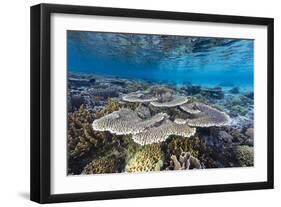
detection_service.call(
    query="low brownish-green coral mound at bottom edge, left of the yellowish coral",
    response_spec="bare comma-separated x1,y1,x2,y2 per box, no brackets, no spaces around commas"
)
81,156,118,174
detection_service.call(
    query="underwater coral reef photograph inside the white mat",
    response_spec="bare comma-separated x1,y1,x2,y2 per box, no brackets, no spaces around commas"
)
67,31,254,175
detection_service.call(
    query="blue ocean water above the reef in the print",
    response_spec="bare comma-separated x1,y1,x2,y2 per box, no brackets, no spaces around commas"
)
67,31,254,89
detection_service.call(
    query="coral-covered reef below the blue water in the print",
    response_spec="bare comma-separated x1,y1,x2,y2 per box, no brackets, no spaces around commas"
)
67,73,254,175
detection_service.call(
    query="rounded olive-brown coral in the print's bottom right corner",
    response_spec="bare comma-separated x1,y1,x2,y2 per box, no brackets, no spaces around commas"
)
234,145,254,167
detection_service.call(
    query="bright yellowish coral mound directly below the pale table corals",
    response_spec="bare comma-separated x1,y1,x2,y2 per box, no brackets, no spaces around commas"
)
125,144,163,172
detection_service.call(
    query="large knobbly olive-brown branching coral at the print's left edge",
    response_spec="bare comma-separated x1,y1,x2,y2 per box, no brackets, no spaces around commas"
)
67,105,104,158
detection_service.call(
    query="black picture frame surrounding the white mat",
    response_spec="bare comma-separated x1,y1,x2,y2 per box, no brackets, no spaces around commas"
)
30,4,274,203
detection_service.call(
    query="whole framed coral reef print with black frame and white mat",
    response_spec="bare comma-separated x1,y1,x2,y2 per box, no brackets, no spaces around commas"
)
31,4,273,203
